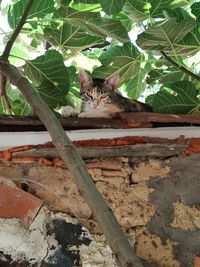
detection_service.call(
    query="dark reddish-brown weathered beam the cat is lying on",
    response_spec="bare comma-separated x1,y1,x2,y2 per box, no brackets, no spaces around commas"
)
0,112,200,131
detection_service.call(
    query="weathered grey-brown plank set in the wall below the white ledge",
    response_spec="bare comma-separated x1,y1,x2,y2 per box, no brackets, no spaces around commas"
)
12,144,187,159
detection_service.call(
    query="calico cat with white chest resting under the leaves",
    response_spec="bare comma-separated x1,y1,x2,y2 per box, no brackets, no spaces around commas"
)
61,70,151,118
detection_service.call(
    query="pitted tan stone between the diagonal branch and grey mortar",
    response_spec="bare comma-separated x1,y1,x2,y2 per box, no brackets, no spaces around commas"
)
96,182,155,232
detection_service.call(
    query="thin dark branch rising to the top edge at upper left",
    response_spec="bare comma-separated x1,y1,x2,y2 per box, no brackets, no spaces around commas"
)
1,0,35,60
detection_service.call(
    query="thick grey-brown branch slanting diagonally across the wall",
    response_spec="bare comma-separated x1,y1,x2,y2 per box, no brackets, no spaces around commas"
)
0,61,143,267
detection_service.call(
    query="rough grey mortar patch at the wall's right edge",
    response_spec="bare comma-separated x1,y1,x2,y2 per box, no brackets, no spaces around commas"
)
147,154,200,267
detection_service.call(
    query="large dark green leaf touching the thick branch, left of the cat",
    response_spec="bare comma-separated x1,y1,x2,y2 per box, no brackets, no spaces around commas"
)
24,50,69,108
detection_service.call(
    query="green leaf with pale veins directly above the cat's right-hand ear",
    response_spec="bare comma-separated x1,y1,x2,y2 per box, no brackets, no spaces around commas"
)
93,43,143,83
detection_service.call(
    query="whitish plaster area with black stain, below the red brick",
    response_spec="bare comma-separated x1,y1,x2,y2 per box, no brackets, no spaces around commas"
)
0,208,117,267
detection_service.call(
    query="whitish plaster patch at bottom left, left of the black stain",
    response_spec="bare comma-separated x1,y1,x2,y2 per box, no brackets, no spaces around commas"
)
0,209,58,266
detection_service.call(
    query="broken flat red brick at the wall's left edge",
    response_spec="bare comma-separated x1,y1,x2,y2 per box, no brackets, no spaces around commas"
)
0,184,42,227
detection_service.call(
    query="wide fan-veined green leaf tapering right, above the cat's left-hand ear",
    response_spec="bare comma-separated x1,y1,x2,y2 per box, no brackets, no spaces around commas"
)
44,22,103,52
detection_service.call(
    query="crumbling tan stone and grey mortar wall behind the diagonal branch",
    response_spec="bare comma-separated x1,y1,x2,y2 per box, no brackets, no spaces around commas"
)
0,149,200,267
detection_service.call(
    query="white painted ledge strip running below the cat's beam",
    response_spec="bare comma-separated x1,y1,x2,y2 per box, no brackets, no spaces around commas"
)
0,126,200,150
